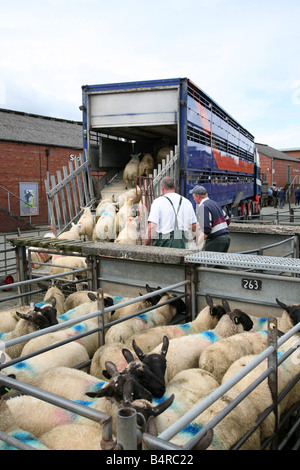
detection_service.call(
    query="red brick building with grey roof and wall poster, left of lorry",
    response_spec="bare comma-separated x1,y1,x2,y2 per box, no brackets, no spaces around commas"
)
0,109,83,232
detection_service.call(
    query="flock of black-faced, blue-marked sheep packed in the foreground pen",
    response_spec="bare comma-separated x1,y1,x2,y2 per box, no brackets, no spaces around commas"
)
0,280,300,450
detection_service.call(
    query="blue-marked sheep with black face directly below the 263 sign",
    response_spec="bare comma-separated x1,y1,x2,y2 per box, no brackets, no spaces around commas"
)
152,309,253,383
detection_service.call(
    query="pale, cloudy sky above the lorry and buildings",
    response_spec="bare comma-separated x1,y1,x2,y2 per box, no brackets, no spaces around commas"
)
0,0,300,149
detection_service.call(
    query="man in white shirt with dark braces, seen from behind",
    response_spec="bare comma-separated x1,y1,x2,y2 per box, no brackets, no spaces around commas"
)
144,176,197,248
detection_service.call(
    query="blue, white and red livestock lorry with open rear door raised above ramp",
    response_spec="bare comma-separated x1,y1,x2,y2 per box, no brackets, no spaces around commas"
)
80,78,261,216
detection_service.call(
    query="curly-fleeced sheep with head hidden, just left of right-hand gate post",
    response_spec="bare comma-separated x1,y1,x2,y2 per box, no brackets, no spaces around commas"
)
199,331,268,383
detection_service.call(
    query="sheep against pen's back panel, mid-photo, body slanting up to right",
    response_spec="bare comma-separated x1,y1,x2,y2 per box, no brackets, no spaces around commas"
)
105,294,186,344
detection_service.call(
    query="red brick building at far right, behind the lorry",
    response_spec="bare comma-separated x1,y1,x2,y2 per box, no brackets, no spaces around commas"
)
256,144,300,187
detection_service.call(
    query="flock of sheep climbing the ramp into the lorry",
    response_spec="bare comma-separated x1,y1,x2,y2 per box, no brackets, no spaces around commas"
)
31,147,172,279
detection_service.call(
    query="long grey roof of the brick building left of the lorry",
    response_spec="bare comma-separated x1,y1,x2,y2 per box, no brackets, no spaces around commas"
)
0,108,83,149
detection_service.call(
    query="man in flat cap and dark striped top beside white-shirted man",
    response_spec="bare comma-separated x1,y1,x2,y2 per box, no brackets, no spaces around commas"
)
190,186,230,253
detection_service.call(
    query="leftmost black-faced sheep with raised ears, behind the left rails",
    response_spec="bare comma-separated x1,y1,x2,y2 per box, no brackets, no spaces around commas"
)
0,298,58,359
